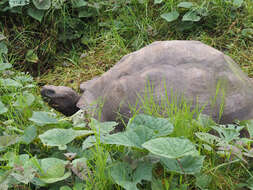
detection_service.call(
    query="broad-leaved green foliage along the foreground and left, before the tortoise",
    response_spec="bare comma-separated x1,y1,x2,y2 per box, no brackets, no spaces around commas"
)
0,39,252,190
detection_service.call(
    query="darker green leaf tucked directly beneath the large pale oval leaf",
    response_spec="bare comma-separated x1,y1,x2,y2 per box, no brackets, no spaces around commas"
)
161,155,205,174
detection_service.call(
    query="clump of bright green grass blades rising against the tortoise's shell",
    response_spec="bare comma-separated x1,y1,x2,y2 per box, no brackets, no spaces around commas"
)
126,83,210,138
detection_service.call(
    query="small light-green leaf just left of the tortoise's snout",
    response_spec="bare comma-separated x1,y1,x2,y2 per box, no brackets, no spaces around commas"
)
13,91,35,109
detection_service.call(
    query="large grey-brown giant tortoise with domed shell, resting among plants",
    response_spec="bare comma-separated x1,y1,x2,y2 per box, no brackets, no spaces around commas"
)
41,40,253,124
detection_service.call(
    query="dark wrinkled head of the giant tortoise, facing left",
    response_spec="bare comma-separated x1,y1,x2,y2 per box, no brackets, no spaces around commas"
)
40,85,80,116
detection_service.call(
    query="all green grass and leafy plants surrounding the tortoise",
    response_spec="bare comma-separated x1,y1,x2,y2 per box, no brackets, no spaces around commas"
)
0,0,253,190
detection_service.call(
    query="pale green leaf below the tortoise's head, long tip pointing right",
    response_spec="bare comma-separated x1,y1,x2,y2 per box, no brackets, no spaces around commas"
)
39,129,94,150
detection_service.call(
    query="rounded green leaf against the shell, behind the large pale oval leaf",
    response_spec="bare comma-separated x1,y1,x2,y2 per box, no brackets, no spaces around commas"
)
127,114,174,138
